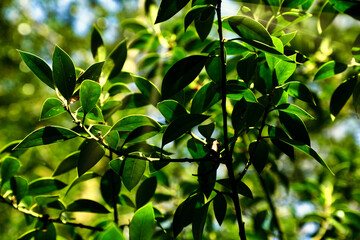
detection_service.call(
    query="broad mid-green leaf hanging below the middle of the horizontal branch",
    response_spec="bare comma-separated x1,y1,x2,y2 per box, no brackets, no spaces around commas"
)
122,157,146,191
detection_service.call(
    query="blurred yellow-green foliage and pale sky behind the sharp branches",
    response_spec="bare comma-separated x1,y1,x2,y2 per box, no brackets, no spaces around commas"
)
0,0,360,239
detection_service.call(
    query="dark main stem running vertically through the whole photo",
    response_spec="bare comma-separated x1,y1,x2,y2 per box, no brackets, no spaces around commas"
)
216,0,246,240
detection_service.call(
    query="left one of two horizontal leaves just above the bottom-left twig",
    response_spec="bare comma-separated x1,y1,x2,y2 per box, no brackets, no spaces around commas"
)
27,178,67,196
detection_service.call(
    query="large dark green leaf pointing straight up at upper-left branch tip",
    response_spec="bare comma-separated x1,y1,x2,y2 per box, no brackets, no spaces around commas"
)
52,46,76,100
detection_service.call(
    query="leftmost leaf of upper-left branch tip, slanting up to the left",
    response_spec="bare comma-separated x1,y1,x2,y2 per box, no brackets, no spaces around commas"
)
18,50,55,89
